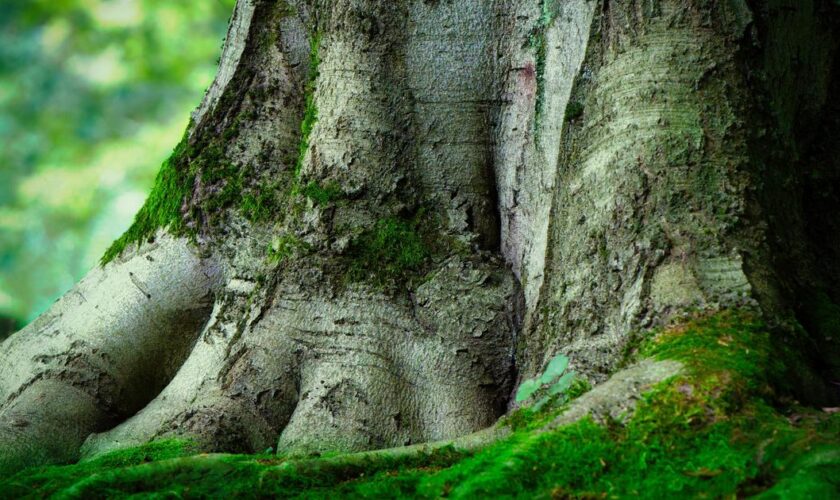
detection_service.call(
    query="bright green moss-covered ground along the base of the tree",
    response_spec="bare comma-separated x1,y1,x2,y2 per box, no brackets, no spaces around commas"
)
0,312,840,498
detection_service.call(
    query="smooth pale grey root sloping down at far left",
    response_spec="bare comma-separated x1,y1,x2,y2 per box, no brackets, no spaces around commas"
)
0,236,220,469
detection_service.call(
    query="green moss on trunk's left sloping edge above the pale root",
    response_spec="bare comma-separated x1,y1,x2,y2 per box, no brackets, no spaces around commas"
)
101,23,310,265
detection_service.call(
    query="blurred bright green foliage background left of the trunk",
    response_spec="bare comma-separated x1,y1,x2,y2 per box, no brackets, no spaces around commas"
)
0,0,234,338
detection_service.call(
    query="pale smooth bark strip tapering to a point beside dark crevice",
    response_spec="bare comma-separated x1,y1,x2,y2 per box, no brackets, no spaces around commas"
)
495,0,599,324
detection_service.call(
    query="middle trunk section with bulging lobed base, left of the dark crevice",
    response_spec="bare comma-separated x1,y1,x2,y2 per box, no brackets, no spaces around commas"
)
84,1,518,460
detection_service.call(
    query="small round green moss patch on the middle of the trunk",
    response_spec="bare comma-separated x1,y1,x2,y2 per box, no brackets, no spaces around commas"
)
347,210,431,285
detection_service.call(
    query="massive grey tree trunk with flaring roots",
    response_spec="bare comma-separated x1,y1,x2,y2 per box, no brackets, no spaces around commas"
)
0,0,840,484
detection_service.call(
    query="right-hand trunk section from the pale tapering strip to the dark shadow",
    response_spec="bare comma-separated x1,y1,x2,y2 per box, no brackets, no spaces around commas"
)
497,0,838,386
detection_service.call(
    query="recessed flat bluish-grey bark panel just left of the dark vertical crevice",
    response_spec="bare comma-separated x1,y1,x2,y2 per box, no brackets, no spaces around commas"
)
403,2,500,250
